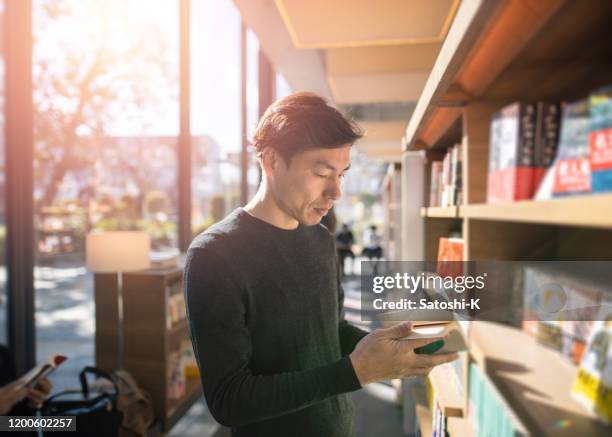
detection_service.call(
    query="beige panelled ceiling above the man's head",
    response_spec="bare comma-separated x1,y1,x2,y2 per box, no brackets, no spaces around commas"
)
234,0,459,160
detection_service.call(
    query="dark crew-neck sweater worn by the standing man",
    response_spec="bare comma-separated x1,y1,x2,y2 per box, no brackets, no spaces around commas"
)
185,208,367,437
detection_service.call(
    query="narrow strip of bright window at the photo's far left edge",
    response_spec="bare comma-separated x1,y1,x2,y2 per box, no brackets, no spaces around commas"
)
0,1,8,345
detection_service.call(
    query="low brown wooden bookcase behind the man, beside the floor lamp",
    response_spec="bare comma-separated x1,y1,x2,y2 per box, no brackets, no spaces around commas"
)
95,267,202,432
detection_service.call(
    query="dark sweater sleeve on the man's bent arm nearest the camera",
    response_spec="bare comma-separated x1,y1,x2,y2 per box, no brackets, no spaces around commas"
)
185,248,361,427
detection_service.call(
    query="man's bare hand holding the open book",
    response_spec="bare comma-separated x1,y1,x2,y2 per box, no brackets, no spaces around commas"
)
350,322,457,386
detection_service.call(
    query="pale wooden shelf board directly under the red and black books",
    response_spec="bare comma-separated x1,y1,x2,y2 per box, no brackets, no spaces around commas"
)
459,194,612,228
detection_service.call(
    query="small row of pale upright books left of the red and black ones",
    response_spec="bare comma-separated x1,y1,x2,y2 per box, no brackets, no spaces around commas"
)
429,144,462,207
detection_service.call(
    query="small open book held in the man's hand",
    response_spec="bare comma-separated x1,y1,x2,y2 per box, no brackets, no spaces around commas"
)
404,320,467,355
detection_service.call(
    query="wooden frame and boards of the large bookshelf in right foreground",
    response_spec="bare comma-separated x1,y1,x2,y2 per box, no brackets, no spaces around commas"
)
402,0,612,436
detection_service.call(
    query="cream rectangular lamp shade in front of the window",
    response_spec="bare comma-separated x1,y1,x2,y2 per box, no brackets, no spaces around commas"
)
85,231,151,273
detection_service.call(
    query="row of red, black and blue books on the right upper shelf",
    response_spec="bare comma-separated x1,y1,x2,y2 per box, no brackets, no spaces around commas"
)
488,87,612,203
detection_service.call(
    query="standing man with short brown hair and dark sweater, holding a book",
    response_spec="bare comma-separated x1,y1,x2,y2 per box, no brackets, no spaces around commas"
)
185,93,455,437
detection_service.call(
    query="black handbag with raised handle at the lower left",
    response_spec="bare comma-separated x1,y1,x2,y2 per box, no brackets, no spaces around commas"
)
41,366,122,437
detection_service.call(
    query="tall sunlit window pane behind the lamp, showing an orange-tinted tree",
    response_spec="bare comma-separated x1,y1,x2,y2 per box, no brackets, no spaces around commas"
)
33,0,179,386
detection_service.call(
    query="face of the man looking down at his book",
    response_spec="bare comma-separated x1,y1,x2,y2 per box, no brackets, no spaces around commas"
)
269,144,351,225
